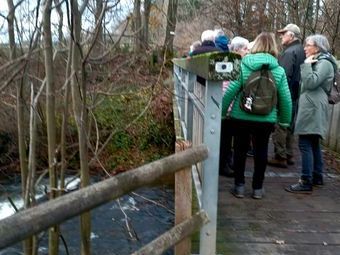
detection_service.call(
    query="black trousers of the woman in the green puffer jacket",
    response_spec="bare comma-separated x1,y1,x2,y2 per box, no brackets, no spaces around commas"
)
233,119,274,189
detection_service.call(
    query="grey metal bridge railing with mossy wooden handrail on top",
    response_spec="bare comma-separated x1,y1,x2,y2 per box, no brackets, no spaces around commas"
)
173,53,240,255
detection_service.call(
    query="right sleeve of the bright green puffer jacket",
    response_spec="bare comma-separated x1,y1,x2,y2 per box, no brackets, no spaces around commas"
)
277,73,292,127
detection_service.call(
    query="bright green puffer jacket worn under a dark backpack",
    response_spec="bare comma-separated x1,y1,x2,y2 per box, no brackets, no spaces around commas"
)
222,53,292,127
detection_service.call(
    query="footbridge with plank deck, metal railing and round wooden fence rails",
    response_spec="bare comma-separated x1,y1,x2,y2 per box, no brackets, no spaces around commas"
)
0,53,340,255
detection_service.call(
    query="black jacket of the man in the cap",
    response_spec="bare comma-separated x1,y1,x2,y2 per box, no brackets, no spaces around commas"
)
278,40,306,101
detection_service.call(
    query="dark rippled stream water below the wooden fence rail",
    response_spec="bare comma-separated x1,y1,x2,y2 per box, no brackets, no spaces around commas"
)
0,177,174,255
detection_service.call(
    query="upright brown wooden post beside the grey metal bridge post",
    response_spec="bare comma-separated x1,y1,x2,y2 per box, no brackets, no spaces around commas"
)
175,140,192,255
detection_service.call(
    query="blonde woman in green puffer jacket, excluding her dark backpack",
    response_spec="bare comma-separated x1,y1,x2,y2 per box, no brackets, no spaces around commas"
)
222,32,292,199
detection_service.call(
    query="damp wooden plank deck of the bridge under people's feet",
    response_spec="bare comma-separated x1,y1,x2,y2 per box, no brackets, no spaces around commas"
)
216,140,340,255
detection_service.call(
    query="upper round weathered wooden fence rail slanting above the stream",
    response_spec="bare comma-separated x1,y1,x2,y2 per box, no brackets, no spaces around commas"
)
0,145,208,249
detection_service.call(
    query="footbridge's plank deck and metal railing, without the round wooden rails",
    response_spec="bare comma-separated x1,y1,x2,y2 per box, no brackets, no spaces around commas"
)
174,53,340,255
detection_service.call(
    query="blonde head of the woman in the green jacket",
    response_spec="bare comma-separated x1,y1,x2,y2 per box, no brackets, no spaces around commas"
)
250,32,279,57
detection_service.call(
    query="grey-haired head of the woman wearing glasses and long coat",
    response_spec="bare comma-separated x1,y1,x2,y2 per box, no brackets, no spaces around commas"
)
304,34,330,57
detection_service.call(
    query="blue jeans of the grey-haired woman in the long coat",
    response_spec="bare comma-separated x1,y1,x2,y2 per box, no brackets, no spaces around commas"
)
299,135,323,182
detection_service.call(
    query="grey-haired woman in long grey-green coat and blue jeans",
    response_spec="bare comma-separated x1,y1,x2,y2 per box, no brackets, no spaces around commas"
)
286,34,336,193
